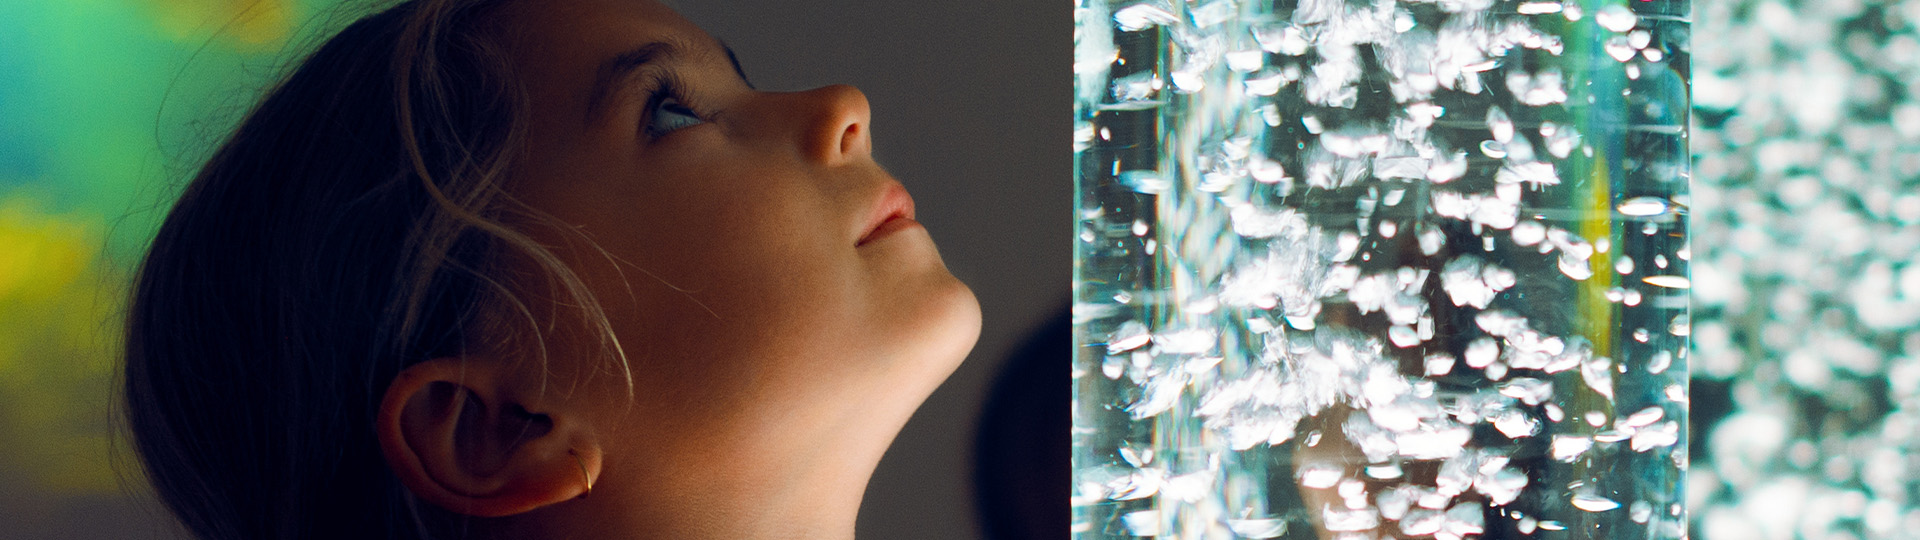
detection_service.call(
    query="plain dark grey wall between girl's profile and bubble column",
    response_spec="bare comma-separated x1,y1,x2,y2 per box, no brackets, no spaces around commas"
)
674,0,1073,540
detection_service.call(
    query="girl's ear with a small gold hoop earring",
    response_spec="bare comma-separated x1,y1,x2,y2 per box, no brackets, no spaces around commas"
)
374,357,601,517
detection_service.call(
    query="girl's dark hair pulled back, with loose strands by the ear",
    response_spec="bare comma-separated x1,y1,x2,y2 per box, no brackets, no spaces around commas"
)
123,0,632,538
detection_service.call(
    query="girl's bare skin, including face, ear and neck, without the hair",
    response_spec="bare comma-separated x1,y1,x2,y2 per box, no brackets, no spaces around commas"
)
368,0,979,538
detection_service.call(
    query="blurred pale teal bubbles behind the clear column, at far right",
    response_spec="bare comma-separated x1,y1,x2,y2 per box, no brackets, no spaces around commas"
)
1678,0,1920,540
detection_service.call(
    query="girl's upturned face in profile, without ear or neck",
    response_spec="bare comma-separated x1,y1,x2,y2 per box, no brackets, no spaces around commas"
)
487,0,979,445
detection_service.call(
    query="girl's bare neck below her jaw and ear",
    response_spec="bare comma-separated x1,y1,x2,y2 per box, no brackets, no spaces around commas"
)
501,390,912,540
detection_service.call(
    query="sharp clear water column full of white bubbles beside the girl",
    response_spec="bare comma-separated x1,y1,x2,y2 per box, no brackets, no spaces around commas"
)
1071,0,1690,540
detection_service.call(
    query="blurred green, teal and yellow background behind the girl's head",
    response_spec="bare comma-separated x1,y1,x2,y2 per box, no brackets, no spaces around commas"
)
0,0,326,538
